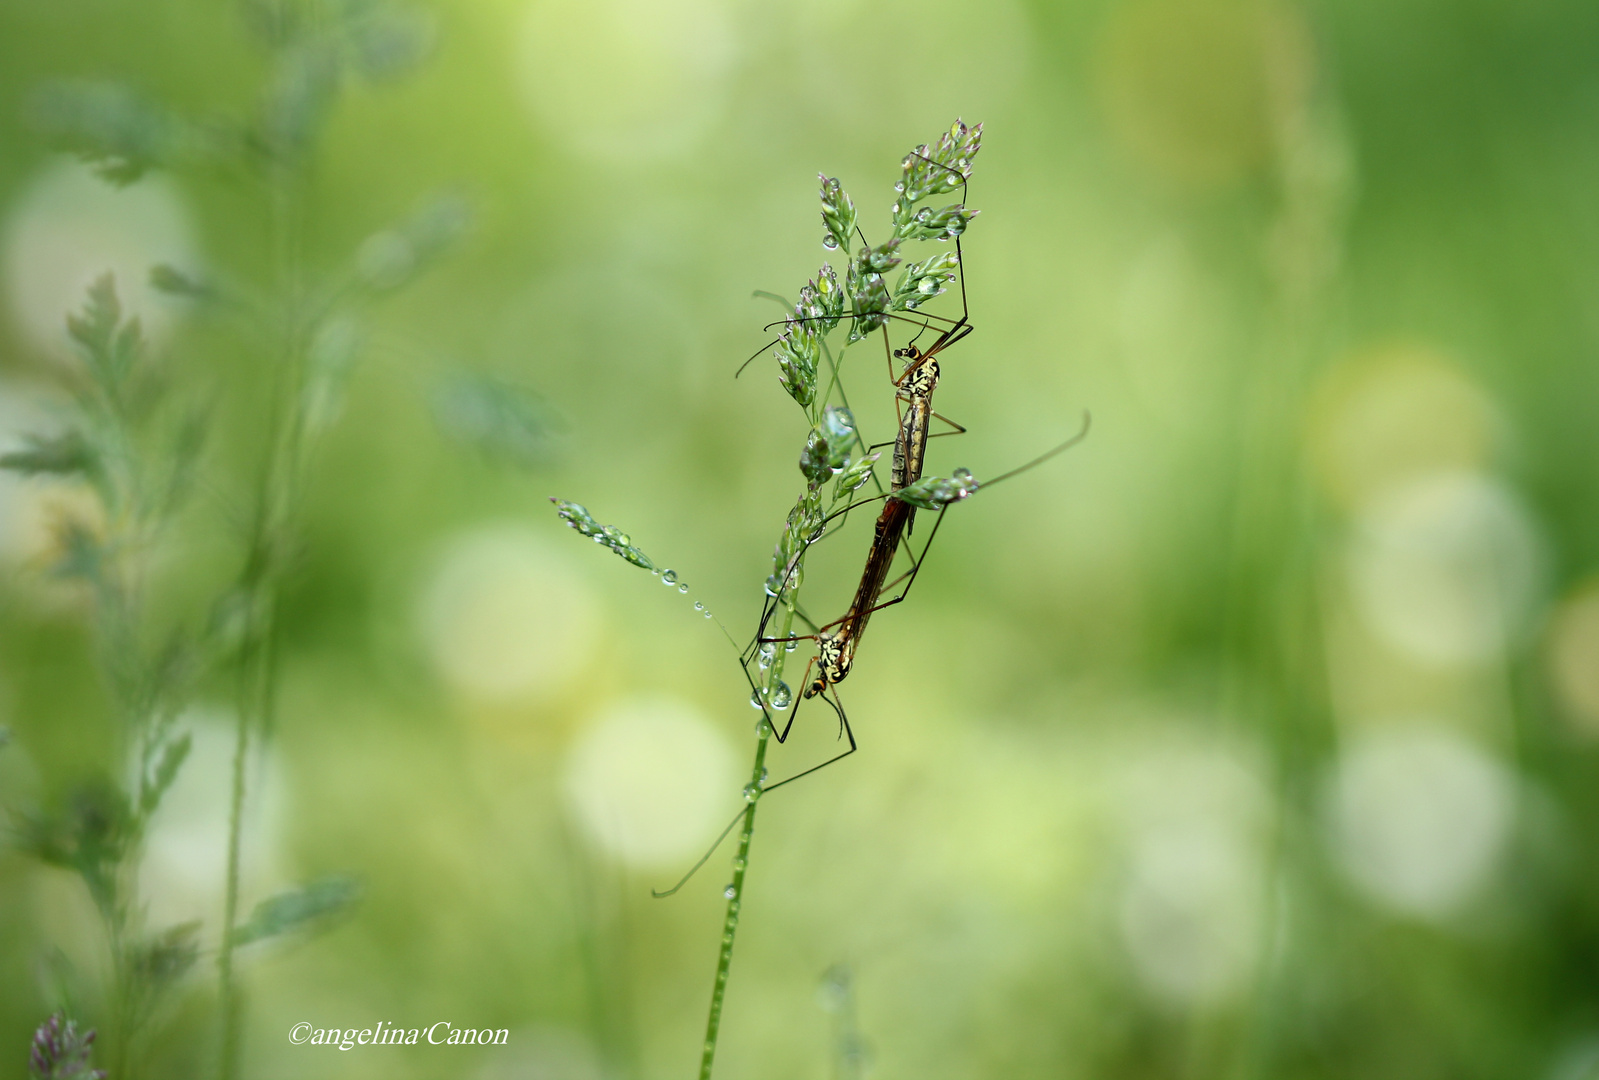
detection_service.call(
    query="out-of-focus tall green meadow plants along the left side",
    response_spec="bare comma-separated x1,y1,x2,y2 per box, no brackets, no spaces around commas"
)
0,0,463,1080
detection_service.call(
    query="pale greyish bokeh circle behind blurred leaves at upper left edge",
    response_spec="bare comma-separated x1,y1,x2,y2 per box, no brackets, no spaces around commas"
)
0,160,198,357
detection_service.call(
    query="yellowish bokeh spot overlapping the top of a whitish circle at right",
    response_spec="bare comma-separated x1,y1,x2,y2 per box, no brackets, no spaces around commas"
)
1310,344,1500,510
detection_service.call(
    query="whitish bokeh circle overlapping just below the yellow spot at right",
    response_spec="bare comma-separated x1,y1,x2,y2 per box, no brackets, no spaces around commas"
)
1348,470,1540,667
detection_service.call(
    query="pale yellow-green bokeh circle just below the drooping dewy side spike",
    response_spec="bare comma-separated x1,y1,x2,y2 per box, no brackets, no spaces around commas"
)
419,525,600,704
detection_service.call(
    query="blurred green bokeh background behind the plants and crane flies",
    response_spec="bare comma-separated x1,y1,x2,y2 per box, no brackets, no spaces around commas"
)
0,0,1599,1080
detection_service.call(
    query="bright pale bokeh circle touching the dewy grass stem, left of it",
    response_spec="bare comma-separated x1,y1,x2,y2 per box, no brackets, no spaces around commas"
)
566,699,737,869
